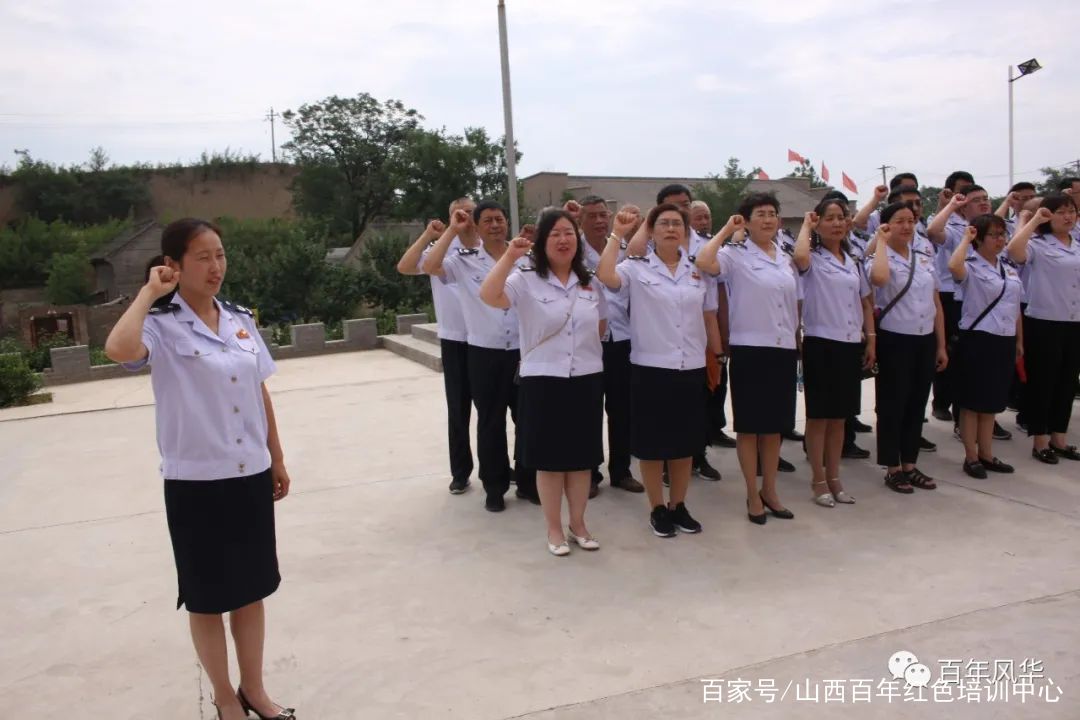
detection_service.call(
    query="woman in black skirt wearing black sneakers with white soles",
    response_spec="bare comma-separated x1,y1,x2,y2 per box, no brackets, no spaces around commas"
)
596,203,720,538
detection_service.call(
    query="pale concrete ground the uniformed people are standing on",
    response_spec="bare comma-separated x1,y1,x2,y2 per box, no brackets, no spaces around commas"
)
0,351,1080,720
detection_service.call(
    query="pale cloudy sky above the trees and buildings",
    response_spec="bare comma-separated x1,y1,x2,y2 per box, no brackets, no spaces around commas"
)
0,0,1080,200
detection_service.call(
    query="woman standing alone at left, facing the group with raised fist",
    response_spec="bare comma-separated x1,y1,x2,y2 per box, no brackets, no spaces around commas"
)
105,218,293,720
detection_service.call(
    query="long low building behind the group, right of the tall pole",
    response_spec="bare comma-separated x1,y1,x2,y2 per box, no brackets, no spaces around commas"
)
522,173,827,233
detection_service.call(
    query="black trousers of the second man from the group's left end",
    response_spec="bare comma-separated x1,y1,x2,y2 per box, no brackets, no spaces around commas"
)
468,345,536,495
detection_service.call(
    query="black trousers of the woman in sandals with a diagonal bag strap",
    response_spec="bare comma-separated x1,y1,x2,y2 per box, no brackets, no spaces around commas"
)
874,329,937,467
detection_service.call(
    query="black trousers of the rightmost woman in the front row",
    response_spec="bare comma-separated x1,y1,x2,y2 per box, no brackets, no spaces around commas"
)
1024,317,1080,435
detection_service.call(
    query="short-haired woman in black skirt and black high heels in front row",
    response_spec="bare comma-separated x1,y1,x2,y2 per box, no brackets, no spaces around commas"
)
697,192,798,525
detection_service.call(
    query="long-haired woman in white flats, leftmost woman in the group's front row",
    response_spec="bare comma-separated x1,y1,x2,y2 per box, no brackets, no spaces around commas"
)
480,210,607,556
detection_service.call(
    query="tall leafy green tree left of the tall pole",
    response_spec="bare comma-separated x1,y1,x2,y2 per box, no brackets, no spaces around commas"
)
282,93,421,237
